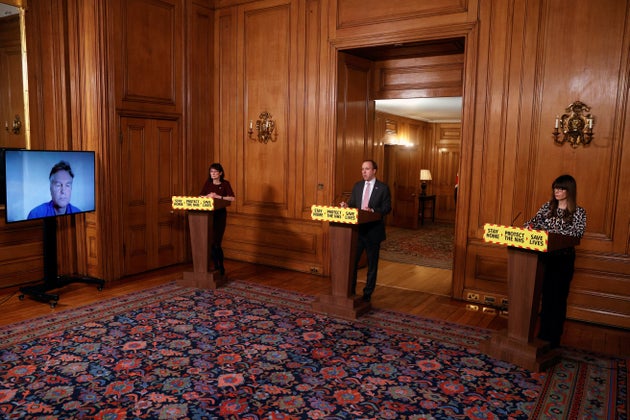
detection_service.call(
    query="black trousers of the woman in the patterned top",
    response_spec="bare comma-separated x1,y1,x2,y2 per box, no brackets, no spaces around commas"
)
538,248,575,347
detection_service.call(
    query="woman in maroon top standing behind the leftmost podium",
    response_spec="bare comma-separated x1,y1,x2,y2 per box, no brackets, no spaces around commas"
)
201,162,235,275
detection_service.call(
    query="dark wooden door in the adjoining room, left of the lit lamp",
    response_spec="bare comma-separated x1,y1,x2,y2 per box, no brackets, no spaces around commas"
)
386,146,420,229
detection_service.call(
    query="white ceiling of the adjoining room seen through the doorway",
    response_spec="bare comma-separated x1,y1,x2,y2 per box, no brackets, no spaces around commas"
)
376,97,462,123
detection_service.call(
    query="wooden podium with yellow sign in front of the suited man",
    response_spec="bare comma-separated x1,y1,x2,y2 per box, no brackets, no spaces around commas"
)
311,206,382,319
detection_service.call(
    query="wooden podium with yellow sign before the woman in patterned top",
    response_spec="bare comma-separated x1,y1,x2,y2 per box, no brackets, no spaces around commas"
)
480,224,580,372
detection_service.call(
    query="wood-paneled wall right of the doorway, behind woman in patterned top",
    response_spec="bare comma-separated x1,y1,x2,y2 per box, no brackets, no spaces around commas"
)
463,1,630,327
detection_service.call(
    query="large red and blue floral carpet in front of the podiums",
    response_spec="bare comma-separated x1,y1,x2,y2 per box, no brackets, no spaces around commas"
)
0,281,628,419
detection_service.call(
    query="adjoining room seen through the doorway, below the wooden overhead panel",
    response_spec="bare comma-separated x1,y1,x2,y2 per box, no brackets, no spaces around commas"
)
375,98,461,296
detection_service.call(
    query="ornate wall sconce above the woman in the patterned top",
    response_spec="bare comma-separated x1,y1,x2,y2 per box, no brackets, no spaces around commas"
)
552,101,593,147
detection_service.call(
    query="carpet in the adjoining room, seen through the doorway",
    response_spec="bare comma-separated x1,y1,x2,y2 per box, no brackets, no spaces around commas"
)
380,223,455,269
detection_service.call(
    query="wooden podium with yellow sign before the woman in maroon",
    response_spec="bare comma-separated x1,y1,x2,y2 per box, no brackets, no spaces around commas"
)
172,196,230,289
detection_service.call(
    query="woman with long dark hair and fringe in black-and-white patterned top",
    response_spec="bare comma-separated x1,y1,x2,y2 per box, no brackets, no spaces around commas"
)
525,175,586,348
